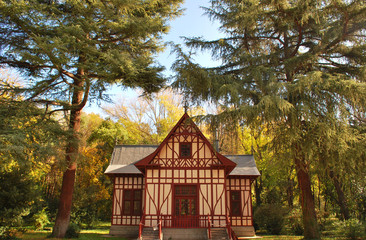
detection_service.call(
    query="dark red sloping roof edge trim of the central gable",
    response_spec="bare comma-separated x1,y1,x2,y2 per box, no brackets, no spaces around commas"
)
135,113,236,173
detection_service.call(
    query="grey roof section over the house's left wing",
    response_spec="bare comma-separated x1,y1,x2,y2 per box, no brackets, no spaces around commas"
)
104,145,158,174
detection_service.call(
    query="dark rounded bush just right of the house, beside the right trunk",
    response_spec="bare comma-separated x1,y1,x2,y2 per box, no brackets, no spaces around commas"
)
254,204,287,235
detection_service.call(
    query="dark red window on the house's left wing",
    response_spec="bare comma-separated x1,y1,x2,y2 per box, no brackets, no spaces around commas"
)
123,189,142,216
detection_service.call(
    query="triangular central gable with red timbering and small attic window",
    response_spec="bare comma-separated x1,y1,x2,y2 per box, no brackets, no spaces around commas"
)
135,113,236,172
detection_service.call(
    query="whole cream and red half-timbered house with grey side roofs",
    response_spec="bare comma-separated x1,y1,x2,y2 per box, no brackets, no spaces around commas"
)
105,113,260,240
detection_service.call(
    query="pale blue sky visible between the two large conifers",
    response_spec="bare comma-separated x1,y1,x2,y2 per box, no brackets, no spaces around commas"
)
83,0,223,115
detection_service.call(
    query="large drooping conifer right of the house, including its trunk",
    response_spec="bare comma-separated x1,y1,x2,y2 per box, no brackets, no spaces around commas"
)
174,0,366,239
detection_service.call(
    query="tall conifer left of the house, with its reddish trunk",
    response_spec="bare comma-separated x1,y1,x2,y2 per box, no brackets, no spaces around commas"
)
0,0,182,237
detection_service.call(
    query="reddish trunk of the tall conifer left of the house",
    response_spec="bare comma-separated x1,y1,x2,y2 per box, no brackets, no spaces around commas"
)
52,78,84,238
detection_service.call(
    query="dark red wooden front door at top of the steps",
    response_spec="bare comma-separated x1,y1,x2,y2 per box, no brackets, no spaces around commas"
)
173,185,199,228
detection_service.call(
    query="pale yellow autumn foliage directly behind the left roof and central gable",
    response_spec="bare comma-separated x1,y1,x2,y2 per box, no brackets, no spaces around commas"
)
101,89,203,144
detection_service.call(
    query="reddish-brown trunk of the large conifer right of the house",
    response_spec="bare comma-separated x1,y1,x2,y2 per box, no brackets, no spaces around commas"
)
295,156,320,239
